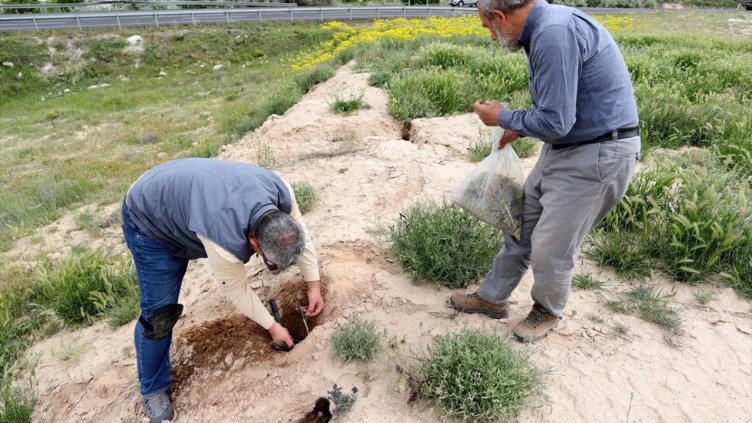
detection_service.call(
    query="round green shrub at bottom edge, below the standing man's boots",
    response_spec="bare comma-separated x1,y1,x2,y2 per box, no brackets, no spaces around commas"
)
419,329,543,422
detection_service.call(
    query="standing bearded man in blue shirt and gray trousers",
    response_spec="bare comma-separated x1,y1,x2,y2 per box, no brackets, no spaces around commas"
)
450,0,640,342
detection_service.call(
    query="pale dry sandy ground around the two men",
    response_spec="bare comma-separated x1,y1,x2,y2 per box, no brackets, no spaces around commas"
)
13,61,752,423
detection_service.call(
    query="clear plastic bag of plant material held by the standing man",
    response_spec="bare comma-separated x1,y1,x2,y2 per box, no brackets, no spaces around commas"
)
452,126,524,239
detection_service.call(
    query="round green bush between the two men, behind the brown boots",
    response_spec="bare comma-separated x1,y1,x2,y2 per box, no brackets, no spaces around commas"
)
389,202,503,288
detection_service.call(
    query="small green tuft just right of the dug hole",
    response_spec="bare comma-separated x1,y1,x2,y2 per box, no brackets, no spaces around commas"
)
330,320,384,362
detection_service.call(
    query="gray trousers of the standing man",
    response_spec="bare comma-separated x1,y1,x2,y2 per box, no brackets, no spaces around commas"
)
478,137,640,317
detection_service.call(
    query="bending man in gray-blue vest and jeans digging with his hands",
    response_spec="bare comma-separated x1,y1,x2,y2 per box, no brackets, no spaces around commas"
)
123,159,324,423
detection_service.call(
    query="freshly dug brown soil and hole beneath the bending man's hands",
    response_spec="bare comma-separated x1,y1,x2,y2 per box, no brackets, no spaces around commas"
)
170,275,330,398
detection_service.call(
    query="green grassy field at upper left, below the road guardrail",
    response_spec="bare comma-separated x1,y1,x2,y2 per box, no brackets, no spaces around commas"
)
0,24,334,251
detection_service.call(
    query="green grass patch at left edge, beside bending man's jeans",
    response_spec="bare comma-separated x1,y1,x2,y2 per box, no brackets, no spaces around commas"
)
0,247,139,423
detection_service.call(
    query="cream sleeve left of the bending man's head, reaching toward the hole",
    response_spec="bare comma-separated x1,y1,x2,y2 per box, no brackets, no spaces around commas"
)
196,234,274,330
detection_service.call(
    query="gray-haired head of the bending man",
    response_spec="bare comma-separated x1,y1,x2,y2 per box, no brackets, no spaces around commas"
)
256,210,305,269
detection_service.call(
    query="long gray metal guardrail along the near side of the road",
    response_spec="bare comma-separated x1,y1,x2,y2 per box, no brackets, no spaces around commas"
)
0,6,477,31
